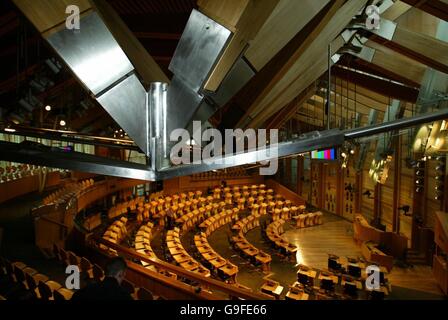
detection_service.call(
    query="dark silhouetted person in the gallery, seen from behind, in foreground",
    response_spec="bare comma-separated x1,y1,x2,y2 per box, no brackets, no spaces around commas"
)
72,257,133,301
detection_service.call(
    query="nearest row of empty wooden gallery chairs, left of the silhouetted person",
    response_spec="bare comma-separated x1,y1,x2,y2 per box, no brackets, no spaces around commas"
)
0,258,73,300
